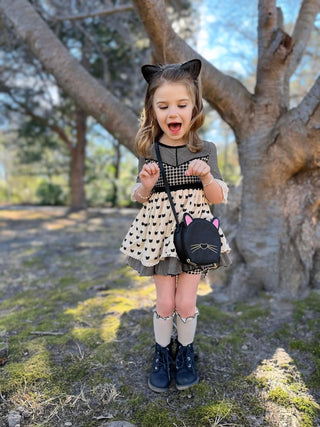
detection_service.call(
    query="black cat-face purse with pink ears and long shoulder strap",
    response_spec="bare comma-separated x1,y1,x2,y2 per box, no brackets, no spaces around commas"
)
155,143,221,269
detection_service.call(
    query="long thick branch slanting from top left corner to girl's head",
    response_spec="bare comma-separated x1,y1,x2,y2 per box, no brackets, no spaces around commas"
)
0,0,138,152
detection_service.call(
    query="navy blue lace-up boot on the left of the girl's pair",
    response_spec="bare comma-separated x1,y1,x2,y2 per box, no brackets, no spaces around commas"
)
148,343,172,393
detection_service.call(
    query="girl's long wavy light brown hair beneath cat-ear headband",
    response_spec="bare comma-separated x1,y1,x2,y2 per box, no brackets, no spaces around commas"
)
135,60,204,157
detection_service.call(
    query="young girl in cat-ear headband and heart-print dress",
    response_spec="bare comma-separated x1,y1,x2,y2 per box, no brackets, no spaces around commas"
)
121,59,230,392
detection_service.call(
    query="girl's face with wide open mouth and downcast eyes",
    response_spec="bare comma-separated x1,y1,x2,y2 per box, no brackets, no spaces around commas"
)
153,83,194,146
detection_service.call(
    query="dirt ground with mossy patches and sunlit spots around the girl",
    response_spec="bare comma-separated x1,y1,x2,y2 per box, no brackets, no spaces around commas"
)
0,206,320,427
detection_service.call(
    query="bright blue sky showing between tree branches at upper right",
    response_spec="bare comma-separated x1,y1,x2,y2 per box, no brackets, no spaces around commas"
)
193,0,320,150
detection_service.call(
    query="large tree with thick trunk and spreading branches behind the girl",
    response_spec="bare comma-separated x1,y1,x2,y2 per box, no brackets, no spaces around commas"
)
0,0,320,295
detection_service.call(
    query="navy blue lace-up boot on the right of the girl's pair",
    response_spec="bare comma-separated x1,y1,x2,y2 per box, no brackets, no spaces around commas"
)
175,341,199,390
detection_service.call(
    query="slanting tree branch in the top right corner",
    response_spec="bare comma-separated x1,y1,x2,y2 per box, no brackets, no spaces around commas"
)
286,0,320,79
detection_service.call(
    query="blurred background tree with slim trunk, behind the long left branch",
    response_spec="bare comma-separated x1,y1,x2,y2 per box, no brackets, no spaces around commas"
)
0,0,196,209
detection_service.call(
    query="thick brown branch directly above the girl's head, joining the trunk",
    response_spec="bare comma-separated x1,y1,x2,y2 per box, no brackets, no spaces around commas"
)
133,0,251,135
